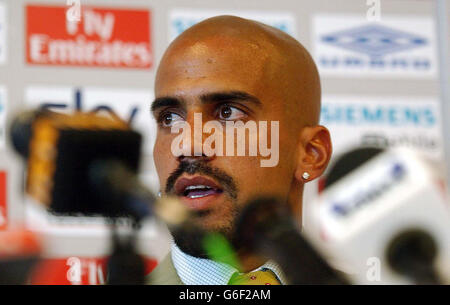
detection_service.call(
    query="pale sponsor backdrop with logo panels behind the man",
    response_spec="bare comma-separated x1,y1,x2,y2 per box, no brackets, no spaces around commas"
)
0,0,442,284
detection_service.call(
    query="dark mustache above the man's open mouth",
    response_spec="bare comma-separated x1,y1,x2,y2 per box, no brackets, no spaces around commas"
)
165,160,238,200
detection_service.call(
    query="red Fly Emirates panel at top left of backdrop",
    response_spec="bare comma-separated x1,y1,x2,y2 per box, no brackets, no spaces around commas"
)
26,5,153,68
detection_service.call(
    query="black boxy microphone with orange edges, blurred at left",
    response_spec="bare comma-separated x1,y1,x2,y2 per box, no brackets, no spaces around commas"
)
10,110,145,217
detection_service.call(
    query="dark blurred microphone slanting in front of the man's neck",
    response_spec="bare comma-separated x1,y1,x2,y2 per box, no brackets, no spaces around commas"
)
233,198,347,285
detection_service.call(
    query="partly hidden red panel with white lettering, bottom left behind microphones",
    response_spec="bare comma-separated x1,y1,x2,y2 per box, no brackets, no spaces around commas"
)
30,256,157,285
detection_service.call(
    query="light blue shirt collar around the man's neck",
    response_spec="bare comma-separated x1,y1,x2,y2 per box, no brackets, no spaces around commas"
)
171,243,286,285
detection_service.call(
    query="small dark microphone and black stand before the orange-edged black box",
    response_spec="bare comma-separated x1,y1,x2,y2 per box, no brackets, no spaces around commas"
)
90,160,155,285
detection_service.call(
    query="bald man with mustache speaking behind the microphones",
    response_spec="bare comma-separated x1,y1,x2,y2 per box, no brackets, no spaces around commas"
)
148,16,332,285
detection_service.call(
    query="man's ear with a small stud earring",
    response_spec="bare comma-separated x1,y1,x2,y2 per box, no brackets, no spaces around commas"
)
295,125,332,183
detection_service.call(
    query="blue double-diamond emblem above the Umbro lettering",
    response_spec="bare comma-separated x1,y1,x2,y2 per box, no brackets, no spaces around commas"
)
321,24,428,58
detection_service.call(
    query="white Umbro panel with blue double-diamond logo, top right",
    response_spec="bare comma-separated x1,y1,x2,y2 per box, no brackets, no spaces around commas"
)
316,21,435,73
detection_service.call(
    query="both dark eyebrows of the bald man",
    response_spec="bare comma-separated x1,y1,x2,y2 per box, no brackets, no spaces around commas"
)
151,91,262,112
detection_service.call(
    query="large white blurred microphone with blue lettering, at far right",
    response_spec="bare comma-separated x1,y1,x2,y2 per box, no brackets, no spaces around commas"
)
305,148,450,284
